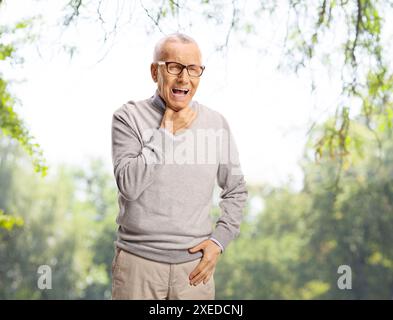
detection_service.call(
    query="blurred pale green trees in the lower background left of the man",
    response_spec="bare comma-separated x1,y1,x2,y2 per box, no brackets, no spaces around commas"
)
0,144,117,299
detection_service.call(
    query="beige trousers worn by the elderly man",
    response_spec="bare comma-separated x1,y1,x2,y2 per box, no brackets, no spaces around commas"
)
112,249,215,300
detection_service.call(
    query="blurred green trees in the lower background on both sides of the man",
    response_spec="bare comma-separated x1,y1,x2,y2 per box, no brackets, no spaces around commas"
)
0,121,393,299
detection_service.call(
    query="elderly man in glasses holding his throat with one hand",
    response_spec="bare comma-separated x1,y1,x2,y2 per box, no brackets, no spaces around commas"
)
112,34,247,299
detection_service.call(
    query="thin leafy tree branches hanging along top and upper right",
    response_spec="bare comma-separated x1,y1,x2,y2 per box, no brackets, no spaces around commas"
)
58,0,393,161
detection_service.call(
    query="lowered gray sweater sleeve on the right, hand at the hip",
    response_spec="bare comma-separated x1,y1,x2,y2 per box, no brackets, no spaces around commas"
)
211,119,248,249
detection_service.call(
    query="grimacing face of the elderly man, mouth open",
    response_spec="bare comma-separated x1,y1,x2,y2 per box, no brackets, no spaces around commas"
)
151,41,201,111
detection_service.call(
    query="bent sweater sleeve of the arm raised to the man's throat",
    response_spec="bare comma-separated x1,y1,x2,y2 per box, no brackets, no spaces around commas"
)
112,109,171,201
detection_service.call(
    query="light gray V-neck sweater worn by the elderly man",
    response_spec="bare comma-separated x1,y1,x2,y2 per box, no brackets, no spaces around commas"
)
112,92,248,263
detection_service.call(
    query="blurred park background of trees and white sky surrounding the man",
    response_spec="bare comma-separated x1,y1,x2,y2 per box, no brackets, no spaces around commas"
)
0,0,393,299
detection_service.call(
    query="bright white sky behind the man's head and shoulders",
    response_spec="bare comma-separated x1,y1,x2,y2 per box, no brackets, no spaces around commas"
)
0,0,350,188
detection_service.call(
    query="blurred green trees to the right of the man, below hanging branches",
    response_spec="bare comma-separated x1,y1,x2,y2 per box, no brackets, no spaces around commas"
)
215,126,393,299
